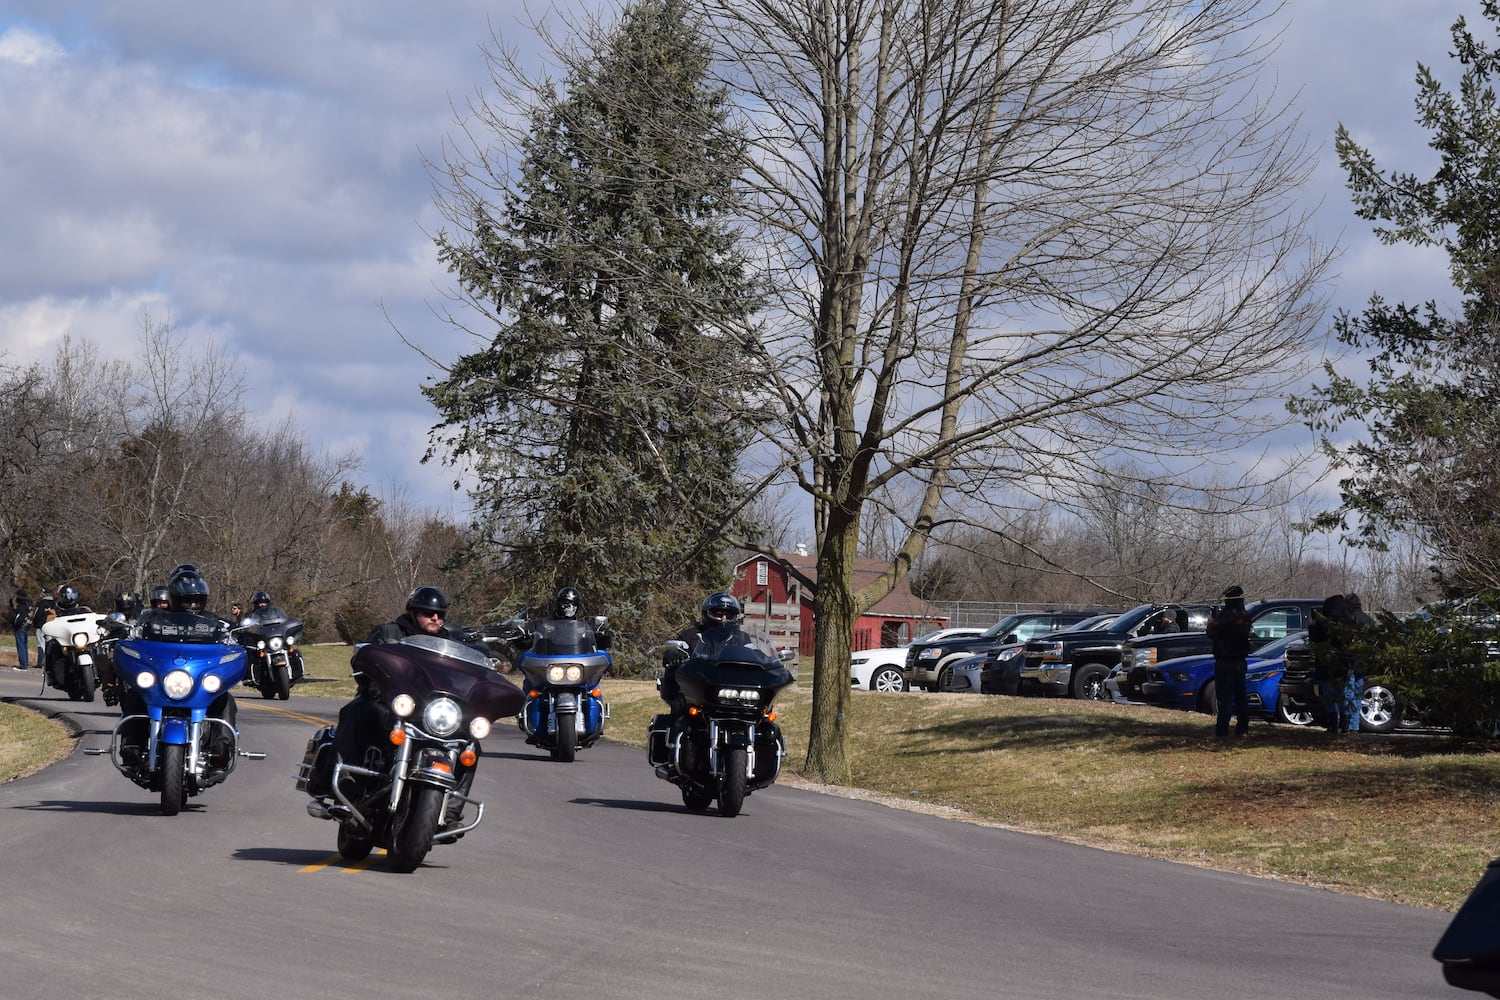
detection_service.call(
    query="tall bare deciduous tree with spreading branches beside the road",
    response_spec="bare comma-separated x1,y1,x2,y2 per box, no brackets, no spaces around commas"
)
702,0,1326,781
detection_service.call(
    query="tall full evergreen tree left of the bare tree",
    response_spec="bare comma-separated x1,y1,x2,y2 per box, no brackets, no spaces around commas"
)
425,0,758,625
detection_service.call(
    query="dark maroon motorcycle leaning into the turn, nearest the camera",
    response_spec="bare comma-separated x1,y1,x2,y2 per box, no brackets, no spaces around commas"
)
297,636,525,871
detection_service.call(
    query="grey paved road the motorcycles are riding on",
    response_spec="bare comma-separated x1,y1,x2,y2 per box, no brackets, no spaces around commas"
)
0,672,1479,1000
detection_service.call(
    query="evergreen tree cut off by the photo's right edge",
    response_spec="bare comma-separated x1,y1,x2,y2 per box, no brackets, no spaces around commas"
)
1292,0,1500,589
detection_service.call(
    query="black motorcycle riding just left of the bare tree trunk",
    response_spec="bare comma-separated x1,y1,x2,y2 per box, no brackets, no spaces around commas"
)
647,627,795,817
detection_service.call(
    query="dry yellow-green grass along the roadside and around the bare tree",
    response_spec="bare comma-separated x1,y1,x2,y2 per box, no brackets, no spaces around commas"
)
0,646,1500,910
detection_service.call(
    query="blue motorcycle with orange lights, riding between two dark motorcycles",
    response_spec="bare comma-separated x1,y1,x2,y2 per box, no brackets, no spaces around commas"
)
516,618,611,762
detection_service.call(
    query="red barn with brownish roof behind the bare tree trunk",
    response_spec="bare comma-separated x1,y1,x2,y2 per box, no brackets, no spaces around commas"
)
729,555,948,657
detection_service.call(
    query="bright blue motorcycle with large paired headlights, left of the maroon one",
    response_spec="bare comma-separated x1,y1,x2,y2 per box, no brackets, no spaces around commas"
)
84,612,266,816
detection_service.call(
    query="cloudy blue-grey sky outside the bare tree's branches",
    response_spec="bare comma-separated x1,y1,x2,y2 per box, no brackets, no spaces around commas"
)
0,0,1484,514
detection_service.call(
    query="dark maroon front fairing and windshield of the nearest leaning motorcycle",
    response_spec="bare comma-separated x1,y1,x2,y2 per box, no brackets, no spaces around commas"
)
353,636,527,720
